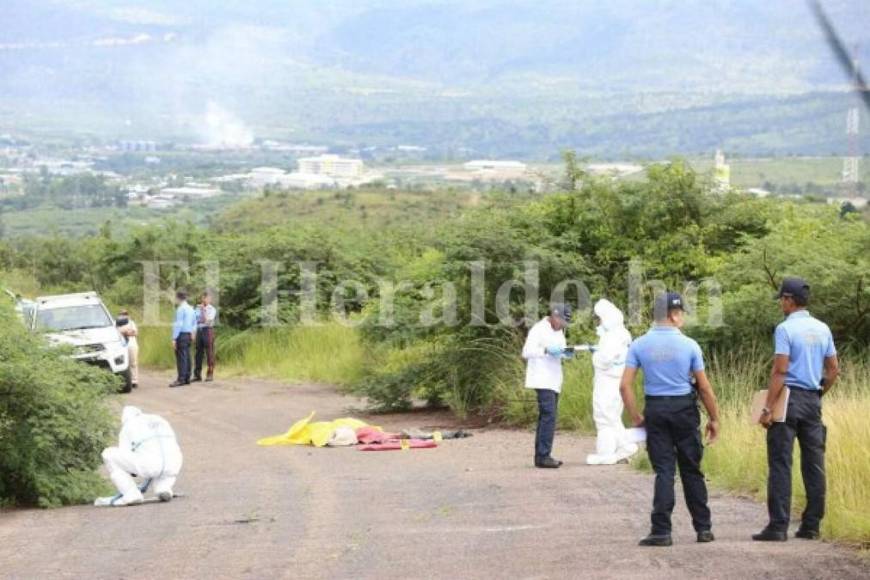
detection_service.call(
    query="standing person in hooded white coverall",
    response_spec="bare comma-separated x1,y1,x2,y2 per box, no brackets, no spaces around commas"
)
586,299,637,465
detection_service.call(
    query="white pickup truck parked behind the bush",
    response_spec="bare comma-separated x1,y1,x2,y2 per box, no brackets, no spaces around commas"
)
28,292,133,393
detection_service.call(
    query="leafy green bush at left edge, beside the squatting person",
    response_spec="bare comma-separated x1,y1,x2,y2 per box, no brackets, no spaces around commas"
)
0,305,118,507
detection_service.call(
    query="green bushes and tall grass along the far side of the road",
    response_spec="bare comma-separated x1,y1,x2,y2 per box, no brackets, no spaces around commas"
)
0,156,870,543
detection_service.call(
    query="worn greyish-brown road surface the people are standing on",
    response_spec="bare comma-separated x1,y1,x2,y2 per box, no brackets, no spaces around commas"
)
0,375,870,580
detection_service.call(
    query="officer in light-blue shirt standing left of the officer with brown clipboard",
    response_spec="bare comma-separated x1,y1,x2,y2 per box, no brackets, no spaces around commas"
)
620,292,719,546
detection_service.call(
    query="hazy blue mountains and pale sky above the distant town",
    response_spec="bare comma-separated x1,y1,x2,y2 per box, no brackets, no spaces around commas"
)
0,0,870,157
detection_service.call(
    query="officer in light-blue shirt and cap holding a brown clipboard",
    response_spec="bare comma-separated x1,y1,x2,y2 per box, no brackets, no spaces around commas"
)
752,278,839,542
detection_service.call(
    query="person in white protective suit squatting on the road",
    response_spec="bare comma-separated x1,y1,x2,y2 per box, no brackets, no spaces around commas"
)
94,406,183,506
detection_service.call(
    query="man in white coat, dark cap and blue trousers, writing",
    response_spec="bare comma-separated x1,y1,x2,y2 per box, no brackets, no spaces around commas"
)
523,304,571,469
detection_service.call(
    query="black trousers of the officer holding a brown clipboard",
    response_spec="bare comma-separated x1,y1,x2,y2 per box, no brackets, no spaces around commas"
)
767,388,827,532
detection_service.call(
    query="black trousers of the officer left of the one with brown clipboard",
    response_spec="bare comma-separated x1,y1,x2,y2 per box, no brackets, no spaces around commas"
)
644,395,712,535
